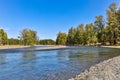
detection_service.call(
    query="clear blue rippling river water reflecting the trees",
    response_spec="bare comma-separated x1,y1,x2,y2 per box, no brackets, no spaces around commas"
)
0,47,120,80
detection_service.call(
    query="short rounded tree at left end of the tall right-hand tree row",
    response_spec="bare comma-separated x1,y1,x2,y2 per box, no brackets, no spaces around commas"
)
56,32,67,45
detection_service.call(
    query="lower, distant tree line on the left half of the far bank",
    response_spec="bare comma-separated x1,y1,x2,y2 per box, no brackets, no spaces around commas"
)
0,29,56,45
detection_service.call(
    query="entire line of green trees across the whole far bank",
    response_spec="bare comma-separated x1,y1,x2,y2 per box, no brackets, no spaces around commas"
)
0,3,120,45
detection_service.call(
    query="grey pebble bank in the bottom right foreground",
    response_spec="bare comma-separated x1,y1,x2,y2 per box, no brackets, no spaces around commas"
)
69,56,120,80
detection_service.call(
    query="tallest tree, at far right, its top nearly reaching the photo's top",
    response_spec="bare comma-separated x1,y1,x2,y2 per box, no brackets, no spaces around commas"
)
107,3,119,45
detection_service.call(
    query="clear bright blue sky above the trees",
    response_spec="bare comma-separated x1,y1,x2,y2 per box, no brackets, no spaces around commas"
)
0,0,120,40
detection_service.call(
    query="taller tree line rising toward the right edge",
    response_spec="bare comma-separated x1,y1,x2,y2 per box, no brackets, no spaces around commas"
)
56,3,120,45
